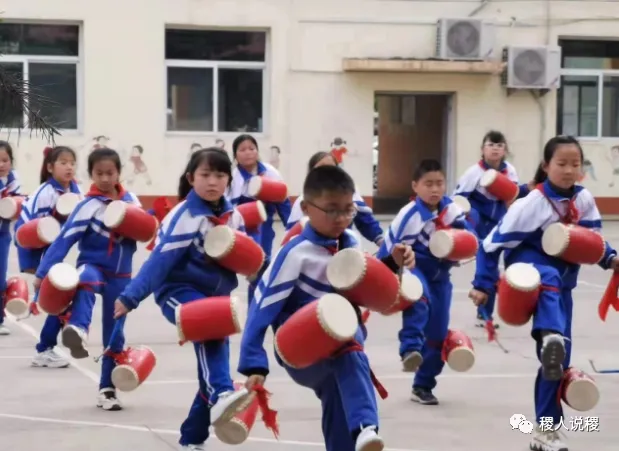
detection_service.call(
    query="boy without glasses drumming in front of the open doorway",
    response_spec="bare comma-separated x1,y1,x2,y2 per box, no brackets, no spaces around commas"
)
377,160,473,405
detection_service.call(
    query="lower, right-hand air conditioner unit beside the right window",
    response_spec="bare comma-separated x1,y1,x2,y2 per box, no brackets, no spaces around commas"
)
502,46,561,90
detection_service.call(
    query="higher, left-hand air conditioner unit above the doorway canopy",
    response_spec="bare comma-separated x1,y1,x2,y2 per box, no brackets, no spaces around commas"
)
436,19,494,61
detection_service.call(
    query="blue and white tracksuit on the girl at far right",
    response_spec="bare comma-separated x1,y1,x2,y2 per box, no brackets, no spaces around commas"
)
473,182,617,425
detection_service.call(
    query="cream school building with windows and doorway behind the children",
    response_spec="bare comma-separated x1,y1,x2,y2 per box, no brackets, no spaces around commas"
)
0,0,619,215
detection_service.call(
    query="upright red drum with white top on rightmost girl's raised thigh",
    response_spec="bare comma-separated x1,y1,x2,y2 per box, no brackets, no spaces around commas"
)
497,263,542,326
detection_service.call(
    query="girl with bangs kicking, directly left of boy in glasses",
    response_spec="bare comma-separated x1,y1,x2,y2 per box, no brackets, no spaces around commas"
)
115,147,248,451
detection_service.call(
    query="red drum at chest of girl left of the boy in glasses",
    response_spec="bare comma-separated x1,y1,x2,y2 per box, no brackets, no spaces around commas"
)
204,225,265,277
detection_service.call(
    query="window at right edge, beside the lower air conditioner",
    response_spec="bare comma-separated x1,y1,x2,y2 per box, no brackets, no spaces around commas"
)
557,40,619,138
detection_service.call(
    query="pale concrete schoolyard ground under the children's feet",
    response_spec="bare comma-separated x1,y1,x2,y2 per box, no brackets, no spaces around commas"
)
0,223,619,451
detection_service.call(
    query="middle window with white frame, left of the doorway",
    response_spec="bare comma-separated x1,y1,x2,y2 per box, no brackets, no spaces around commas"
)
165,30,266,132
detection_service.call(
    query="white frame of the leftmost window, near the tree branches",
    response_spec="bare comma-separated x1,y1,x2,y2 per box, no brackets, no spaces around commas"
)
0,20,84,136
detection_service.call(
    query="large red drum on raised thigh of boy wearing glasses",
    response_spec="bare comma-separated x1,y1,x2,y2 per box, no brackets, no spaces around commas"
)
274,294,359,368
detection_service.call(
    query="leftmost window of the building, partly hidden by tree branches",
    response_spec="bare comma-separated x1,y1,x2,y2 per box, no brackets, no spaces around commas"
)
0,23,79,130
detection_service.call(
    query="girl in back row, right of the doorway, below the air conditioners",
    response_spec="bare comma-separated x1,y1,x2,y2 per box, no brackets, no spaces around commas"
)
454,130,532,328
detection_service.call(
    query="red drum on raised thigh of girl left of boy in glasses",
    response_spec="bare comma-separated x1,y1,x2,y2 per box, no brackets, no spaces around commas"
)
174,296,247,343
